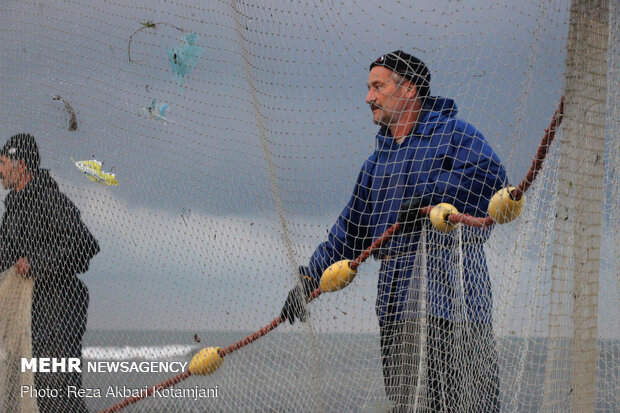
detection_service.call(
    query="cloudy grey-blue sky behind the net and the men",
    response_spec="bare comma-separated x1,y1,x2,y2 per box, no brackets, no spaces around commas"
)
0,0,618,334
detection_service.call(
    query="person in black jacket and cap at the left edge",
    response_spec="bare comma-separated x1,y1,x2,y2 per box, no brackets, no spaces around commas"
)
0,133,99,413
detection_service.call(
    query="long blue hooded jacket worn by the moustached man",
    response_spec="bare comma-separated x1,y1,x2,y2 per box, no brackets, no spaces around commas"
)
308,98,507,325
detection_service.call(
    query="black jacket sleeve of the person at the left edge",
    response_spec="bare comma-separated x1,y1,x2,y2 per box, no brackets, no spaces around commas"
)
28,192,99,277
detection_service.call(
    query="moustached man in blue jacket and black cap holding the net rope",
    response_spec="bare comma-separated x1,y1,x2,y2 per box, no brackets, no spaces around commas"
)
280,50,507,413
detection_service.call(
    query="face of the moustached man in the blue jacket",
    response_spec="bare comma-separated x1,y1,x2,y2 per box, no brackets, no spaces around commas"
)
365,66,415,126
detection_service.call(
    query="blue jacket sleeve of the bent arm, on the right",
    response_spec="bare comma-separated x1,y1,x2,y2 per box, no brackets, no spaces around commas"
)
418,124,507,216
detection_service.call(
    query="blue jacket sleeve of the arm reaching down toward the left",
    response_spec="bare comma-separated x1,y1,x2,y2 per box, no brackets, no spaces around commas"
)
309,161,372,281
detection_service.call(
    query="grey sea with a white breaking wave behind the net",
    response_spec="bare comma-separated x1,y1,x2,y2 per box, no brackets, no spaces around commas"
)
83,330,620,413
